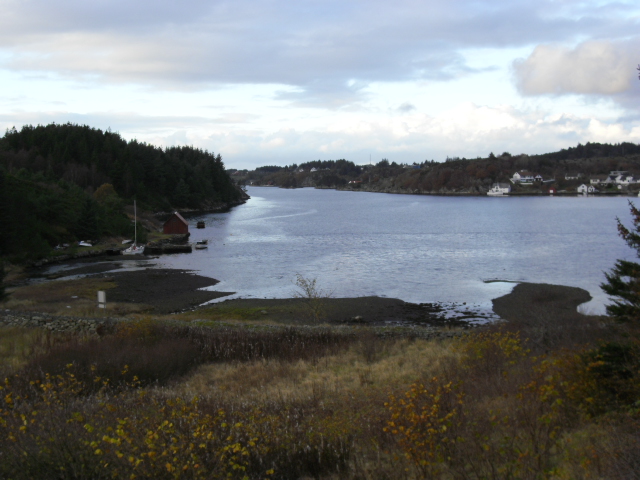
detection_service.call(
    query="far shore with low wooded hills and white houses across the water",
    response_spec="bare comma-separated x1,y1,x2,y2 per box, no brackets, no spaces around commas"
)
227,142,640,196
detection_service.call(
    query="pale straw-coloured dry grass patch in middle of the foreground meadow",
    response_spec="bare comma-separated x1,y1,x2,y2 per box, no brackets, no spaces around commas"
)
172,336,456,405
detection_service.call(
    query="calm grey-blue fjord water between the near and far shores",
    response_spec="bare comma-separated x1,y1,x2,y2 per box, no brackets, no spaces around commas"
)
155,187,633,313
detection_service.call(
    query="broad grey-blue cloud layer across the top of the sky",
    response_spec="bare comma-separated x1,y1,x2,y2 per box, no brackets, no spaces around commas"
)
0,0,638,108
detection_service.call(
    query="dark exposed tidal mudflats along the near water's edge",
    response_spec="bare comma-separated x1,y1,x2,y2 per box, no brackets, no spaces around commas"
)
0,260,592,328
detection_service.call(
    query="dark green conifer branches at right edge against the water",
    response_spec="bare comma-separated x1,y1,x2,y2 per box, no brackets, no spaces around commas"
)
600,202,640,322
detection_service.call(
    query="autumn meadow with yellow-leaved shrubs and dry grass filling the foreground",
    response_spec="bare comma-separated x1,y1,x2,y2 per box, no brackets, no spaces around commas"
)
0,312,640,479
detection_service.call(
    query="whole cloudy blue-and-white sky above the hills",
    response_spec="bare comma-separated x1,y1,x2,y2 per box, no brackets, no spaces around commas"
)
0,0,640,169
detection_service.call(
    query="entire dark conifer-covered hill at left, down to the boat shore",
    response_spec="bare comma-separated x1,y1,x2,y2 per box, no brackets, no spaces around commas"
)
0,124,243,260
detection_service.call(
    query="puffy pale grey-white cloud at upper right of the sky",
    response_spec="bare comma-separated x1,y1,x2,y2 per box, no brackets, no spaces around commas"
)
514,38,640,95
